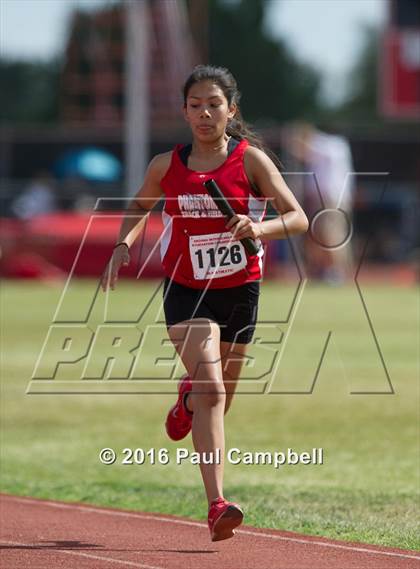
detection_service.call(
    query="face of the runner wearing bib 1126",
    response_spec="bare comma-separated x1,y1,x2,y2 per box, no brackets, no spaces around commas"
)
184,81,236,142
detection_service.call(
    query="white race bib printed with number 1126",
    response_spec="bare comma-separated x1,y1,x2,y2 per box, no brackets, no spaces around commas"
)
190,231,247,280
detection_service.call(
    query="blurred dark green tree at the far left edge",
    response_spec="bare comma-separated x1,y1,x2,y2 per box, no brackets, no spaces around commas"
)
0,59,61,124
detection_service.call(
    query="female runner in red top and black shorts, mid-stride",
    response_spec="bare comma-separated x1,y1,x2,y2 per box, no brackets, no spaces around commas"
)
102,65,308,541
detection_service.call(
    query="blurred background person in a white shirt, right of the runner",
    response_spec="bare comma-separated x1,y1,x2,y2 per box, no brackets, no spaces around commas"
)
286,123,354,284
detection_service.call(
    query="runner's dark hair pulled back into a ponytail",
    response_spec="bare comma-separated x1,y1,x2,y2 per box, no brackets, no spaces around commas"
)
183,65,281,168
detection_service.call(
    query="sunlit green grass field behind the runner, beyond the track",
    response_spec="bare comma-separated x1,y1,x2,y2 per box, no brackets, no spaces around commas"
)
1,281,420,549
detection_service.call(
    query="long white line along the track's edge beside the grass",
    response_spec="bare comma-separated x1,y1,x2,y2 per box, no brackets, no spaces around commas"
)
0,494,420,561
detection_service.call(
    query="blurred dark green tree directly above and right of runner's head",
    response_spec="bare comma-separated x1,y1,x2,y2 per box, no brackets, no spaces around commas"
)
209,0,320,122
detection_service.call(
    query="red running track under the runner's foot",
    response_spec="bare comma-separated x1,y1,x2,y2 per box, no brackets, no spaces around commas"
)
0,494,420,569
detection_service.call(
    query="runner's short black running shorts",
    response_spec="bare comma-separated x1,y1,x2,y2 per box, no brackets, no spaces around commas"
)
163,277,260,344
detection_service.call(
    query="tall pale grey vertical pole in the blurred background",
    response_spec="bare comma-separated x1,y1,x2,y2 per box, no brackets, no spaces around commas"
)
123,0,150,196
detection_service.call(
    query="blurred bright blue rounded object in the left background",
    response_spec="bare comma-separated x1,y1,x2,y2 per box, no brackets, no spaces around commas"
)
54,146,122,182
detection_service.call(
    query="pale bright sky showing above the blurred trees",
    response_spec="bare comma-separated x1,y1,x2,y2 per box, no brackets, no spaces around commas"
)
0,0,388,101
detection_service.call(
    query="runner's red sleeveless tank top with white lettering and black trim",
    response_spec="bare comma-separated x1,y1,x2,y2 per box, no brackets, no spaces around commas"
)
160,139,267,288
